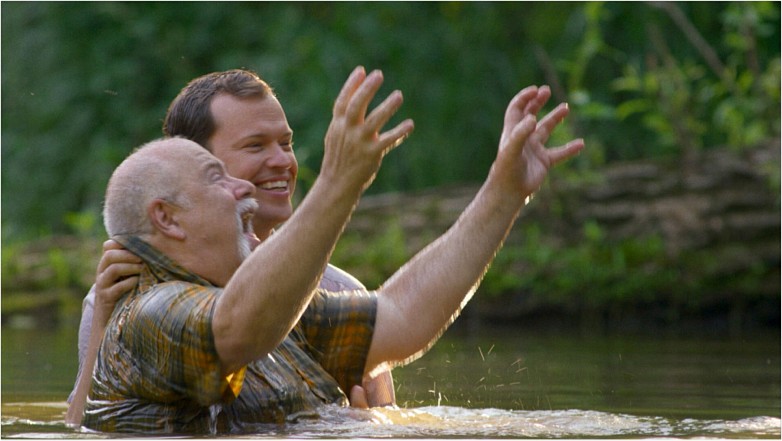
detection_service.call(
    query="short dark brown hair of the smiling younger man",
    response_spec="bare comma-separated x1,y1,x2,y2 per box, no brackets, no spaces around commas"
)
163,69,274,151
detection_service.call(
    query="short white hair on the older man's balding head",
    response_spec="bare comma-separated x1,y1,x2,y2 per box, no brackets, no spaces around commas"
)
103,138,195,237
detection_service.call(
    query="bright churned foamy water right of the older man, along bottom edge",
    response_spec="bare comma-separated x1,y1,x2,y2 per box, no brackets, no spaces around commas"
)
247,406,780,439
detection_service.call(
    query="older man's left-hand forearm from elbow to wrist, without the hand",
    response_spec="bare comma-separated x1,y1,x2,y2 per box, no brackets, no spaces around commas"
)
213,178,359,373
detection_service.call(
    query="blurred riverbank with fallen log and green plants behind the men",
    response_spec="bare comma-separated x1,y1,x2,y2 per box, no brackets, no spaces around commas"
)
2,141,780,335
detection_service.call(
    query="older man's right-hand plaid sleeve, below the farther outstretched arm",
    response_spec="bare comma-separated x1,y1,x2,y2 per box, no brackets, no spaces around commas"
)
300,289,377,393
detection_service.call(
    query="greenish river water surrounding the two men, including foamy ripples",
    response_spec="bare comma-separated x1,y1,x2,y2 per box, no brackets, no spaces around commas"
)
0,326,781,439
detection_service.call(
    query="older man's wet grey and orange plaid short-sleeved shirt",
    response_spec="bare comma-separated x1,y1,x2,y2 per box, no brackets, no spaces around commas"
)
82,237,377,434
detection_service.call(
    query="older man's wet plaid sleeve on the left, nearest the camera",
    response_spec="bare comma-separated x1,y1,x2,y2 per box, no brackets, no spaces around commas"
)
123,282,244,405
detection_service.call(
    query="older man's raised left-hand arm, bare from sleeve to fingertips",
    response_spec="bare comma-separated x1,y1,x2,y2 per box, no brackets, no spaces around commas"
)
212,68,413,374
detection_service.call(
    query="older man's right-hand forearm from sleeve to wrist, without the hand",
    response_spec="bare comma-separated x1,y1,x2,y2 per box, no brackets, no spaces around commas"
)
367,176,523,370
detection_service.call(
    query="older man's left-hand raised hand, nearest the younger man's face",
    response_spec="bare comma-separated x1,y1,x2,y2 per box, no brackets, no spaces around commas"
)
320,67,413,190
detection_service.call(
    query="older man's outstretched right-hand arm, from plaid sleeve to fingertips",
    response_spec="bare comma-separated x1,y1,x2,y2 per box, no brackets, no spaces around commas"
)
366,86,584,371
